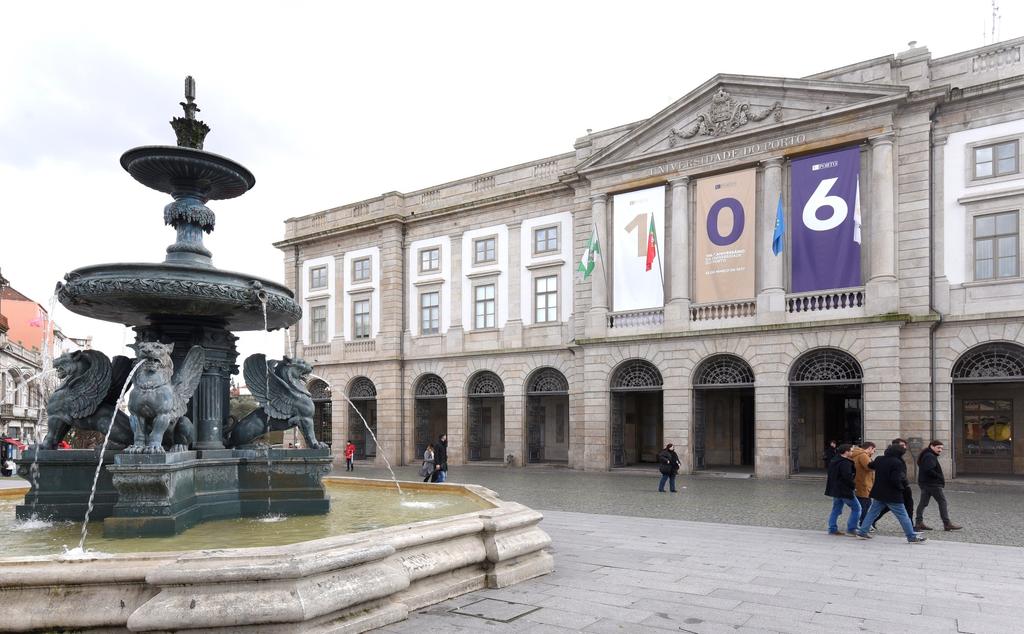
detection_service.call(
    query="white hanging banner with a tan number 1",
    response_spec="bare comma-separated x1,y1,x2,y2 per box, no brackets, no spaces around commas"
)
611,185,665,312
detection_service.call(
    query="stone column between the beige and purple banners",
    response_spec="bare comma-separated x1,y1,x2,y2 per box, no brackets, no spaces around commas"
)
754,157,792,324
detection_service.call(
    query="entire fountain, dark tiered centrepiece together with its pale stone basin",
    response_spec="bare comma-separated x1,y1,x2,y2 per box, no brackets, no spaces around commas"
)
0,78,554,633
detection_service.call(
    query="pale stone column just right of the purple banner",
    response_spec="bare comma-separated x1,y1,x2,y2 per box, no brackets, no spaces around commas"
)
865,132,899,314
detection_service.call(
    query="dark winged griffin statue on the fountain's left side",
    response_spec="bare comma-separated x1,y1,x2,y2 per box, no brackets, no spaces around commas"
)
42,350,132,449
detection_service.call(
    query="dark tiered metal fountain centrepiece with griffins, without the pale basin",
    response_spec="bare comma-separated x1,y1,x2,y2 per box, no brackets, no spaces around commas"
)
17,77,331,537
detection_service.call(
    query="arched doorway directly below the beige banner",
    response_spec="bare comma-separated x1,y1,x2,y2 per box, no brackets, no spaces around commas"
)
693,354,754,470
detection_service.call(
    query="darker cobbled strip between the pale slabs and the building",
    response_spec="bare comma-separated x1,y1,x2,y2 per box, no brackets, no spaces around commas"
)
333,464,1024,548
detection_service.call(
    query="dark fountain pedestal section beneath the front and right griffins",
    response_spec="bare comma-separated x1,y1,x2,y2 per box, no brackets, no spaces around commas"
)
103,449,332,537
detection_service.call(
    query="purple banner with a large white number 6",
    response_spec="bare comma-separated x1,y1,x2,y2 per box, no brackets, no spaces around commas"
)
790,147,861,293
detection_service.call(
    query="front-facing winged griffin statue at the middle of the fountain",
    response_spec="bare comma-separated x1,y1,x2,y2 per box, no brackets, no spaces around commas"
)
125,341,206,454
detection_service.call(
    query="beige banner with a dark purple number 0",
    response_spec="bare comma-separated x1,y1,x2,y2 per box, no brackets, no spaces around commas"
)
693,169,757,304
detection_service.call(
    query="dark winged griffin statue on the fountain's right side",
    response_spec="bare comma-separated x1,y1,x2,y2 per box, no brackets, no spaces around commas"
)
224,354,327,449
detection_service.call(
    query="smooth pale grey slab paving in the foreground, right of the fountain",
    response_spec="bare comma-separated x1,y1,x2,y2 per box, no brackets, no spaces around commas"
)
379,511,1024,634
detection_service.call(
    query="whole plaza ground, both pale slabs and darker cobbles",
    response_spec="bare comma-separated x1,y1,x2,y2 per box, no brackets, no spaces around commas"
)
335,466,1024,634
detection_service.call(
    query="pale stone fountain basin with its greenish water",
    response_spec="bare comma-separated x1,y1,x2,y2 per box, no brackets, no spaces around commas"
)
0,478,554,633
